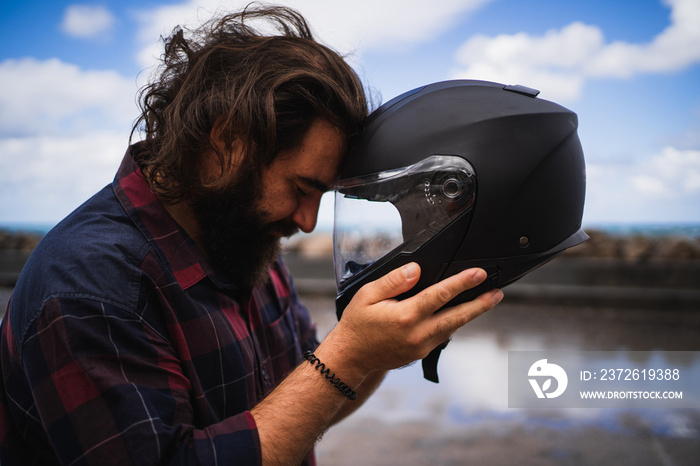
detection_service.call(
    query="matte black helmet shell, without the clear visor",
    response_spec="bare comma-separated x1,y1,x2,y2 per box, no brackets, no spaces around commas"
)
337,80,587,315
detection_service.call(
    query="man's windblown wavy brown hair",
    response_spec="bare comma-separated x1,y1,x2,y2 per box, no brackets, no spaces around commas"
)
132,5,368,203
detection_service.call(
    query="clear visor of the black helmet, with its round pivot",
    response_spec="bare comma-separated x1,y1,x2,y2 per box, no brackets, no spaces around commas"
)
333,155,476,292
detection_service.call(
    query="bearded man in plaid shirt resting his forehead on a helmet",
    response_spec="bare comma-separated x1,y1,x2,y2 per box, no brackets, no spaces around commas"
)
0,4,502,466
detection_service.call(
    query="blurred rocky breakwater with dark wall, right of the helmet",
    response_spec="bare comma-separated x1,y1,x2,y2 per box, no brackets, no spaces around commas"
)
524,230,700,311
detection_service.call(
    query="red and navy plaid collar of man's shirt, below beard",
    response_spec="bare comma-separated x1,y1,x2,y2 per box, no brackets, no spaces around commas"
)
112,145,237,289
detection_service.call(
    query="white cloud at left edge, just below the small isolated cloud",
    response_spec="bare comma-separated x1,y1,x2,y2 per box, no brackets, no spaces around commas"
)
0,58,137,136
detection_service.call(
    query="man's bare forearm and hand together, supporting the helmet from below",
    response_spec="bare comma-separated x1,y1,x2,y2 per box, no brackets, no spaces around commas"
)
251,263,503,465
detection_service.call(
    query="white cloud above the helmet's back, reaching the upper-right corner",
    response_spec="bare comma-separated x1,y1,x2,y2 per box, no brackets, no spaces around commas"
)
453,0,700,101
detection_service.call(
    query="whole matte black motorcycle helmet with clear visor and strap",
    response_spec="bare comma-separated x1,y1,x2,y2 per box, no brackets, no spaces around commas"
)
334,81,588,381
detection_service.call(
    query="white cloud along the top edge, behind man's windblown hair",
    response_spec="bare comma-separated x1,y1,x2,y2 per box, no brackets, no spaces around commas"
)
131,0,493,70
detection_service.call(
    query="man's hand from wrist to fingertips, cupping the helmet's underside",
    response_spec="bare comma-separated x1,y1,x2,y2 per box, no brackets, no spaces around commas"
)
324,263,503,373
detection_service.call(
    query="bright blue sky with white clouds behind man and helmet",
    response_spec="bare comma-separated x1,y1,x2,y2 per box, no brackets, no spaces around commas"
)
0,0,700,228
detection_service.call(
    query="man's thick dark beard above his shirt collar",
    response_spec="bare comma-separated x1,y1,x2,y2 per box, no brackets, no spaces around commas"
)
192,169,298,289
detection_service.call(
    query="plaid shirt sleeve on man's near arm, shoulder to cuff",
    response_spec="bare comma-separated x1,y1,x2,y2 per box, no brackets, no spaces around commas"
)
6,298,262,465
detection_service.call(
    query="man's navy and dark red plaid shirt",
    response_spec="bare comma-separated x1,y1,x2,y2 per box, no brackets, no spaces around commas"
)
0,147,317,466
